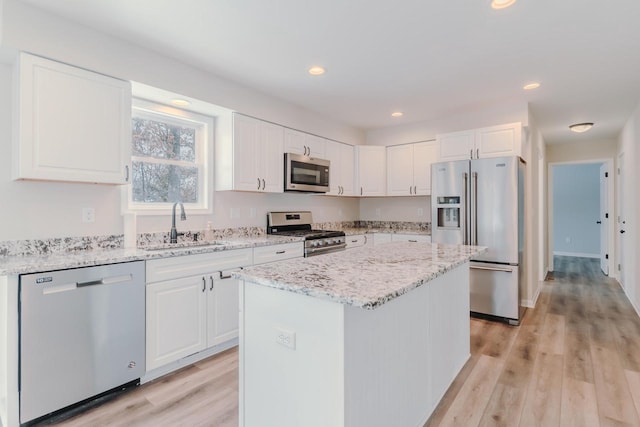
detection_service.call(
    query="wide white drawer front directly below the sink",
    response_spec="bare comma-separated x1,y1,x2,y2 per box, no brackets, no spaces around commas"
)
147,248,253,283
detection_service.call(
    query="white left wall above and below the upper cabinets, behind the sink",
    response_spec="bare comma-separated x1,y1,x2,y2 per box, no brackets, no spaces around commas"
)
0,0,364,241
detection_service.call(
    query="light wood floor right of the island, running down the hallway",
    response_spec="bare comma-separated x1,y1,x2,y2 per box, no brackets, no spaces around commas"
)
427,256,640,427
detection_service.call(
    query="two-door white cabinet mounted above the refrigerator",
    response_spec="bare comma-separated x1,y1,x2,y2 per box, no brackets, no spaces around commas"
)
436,122,524,161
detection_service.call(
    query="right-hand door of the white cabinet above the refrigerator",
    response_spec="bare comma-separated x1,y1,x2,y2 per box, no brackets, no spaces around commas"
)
475,123,522,158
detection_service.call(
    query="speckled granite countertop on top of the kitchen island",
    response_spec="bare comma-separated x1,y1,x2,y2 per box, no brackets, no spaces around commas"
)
234,242,486,309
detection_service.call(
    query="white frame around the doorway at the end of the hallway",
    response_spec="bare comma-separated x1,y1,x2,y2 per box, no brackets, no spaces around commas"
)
547,157,616,271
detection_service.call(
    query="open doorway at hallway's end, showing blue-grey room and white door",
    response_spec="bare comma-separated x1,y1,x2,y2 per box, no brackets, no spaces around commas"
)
548,159,614,275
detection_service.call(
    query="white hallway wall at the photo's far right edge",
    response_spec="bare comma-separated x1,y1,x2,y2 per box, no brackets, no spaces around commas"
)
612,104,640,313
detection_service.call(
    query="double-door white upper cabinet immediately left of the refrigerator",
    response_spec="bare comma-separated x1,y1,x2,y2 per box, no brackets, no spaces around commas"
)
387,142,438,196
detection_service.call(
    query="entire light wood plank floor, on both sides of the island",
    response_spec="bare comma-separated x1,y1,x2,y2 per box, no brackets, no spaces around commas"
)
45,257,640,427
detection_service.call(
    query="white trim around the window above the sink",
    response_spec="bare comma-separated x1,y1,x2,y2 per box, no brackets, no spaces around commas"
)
122,98,214,215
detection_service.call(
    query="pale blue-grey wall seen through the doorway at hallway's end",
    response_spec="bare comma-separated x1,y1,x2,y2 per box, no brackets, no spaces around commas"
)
552,163,602,258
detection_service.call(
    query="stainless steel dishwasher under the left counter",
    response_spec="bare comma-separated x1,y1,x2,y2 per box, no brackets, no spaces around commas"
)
20,261,145,423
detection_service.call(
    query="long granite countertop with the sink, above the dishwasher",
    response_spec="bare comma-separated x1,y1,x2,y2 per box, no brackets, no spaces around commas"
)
0,235,303,276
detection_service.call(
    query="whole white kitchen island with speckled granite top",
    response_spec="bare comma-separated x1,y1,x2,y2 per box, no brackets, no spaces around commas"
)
236,243,485,427
